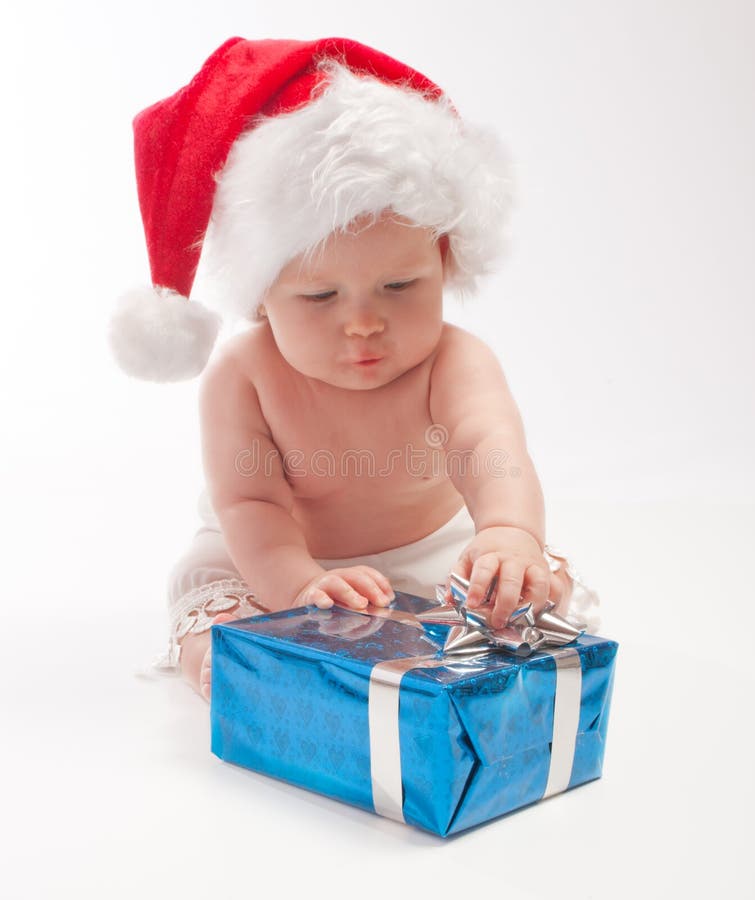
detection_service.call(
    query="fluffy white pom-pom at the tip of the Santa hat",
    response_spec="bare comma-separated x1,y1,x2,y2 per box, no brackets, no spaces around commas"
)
108,287,221,381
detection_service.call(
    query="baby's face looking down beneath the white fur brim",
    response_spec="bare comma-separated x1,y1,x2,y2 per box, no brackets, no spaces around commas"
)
264,214,443,391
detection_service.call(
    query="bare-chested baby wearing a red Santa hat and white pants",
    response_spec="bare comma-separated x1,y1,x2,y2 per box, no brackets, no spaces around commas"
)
111,38,596,699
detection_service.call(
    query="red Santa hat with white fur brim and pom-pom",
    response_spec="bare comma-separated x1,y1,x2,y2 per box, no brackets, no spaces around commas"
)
109,37,513,381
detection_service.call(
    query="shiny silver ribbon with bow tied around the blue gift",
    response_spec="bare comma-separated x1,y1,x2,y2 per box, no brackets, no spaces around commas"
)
368,572,583,822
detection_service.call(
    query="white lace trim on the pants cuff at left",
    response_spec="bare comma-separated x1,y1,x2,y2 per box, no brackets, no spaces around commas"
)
152,578,270,672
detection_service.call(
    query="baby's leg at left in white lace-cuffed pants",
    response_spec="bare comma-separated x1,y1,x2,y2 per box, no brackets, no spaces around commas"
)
163,528,269,696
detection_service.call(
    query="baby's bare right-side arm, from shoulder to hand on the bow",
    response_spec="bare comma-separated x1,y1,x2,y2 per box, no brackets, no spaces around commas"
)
430,326,558,626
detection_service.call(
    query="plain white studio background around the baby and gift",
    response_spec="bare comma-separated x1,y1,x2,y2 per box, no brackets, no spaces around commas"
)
0,0,755,898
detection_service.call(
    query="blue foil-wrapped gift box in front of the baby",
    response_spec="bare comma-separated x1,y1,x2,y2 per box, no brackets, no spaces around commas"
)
210,592,618,836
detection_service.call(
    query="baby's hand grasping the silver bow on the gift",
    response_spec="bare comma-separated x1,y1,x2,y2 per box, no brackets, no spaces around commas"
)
446,526,564,628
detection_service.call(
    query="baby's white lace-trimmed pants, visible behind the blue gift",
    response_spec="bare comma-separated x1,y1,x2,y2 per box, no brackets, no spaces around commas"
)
154,490,600,671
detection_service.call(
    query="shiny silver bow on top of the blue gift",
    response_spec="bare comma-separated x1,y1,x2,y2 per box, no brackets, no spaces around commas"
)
416,572,585,657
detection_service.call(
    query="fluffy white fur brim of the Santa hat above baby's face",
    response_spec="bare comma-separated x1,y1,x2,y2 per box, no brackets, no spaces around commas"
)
195,60,514,318
